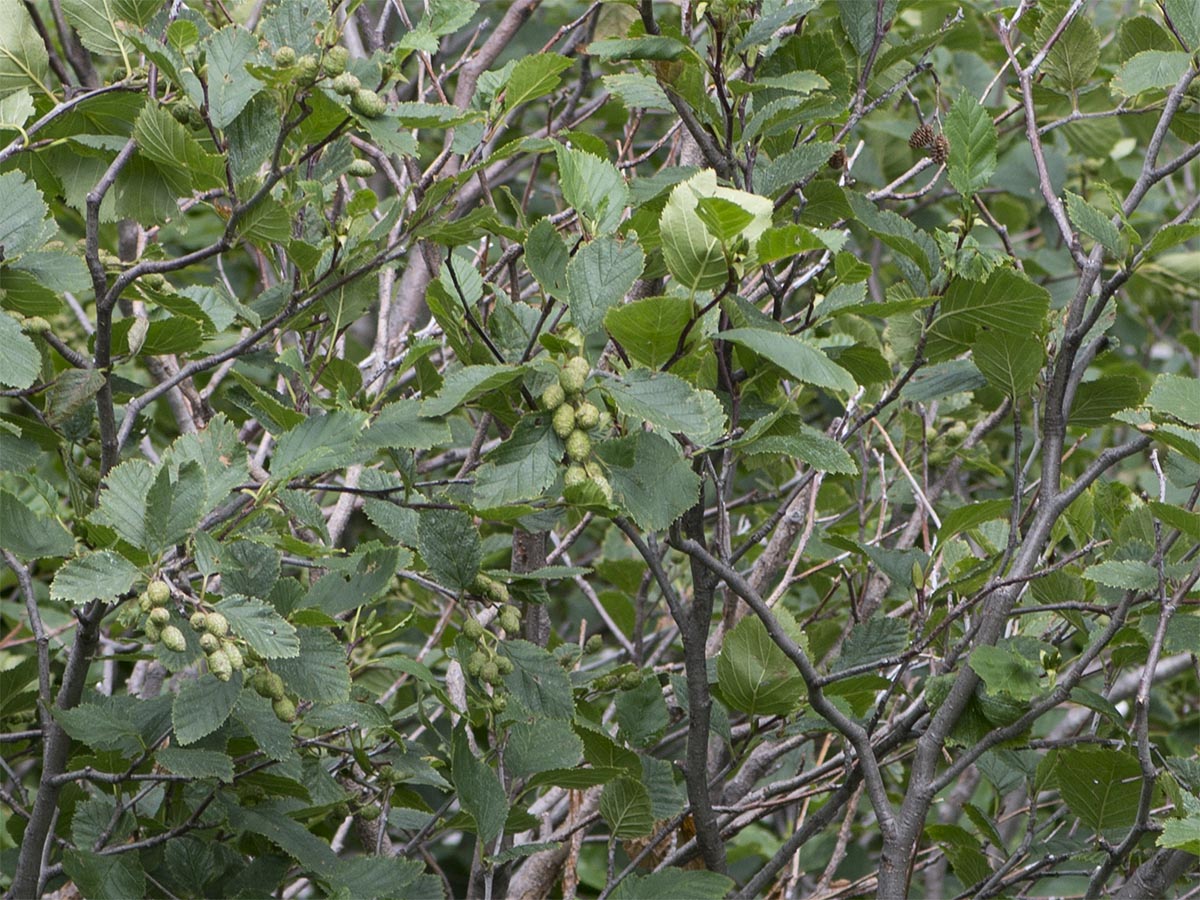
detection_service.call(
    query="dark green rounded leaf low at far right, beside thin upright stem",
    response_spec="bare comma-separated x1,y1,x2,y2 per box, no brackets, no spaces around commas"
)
1056,748,1141,832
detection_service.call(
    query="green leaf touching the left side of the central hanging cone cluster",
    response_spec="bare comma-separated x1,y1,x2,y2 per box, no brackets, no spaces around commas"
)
473,416,563,509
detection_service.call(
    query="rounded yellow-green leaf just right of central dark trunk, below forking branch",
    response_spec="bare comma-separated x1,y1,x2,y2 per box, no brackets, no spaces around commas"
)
716,606,808,715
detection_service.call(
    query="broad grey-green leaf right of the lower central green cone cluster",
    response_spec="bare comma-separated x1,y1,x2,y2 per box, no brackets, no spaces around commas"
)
595,432,700,530
